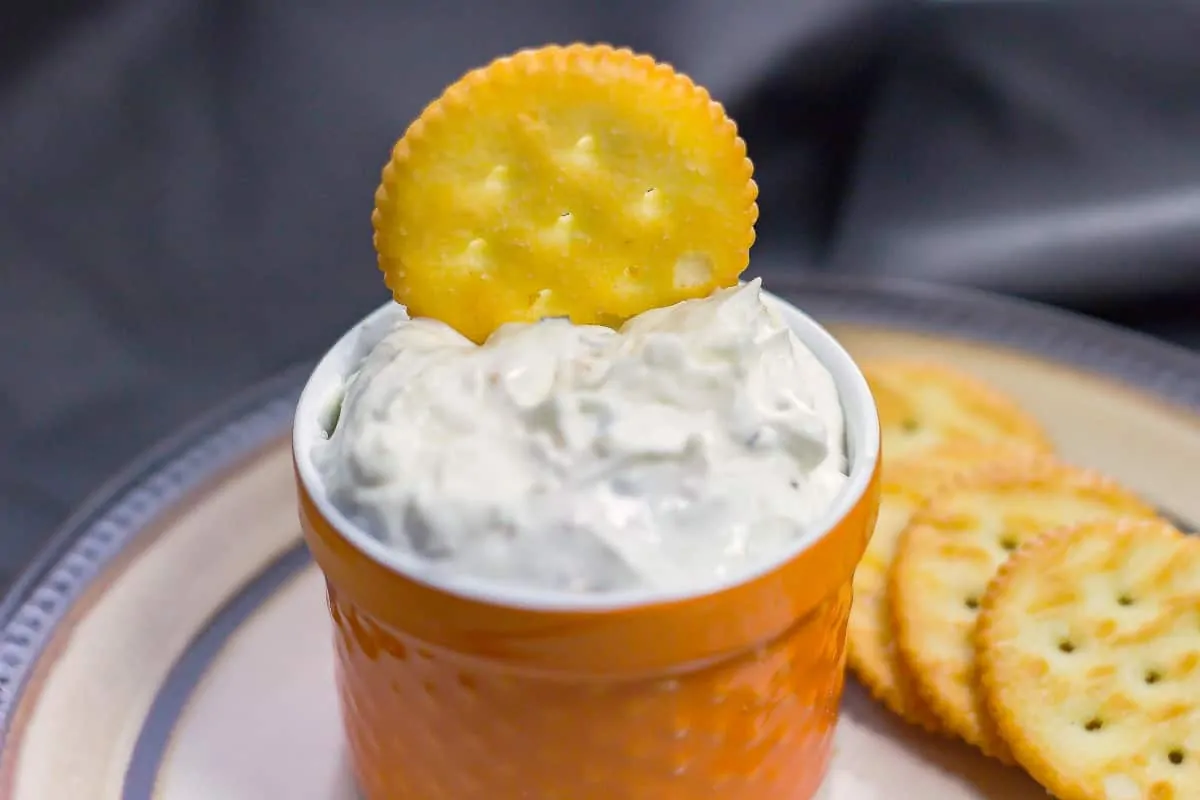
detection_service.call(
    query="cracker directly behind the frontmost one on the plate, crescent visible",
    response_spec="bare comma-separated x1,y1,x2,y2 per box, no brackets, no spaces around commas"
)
888,458,1154,762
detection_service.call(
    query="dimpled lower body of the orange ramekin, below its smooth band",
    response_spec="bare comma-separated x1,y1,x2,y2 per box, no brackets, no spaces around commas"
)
330,561,850,800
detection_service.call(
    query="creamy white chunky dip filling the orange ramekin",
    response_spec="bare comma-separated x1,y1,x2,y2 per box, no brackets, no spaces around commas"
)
313,281,846,593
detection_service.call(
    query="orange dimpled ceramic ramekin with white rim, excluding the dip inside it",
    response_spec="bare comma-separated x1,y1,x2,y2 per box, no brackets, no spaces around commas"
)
294,295,880,800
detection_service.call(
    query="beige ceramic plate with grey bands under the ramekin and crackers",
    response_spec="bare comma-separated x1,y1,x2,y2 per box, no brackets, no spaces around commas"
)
0,278,1200,800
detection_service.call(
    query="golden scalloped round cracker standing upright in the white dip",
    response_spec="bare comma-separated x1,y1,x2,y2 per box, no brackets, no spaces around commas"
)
372,44,758,342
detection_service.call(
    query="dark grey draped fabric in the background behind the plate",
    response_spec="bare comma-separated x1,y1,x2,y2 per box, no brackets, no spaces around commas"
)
0,0,1200,587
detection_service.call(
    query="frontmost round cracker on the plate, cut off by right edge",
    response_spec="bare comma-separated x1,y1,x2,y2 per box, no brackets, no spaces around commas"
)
977,519,1200,800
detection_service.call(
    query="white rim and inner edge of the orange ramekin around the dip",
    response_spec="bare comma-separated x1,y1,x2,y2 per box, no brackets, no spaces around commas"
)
292,290,880,612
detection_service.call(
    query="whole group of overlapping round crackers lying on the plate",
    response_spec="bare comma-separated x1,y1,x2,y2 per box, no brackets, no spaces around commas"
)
847,361,1200,800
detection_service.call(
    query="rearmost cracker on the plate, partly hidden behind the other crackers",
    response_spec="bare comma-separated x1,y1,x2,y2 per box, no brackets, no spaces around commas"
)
862,359,1054,470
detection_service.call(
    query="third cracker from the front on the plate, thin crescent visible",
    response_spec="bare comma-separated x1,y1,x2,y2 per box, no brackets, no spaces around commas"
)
846,443,1033,733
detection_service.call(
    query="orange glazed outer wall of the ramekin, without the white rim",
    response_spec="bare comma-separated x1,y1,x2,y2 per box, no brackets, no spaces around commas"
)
298,474,874,800
